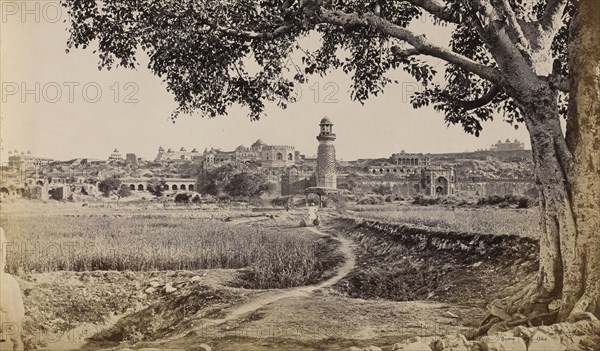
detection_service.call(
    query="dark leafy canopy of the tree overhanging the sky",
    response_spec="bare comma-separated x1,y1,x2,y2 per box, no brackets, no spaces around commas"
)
65,0,571,134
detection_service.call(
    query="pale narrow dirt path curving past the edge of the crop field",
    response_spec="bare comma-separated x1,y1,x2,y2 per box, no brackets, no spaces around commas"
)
185,227,356,329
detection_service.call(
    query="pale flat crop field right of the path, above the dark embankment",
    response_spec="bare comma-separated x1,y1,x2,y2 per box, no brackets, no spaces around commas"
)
349,205,540,238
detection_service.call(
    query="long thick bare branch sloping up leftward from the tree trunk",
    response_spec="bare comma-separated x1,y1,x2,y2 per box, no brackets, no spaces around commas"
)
320,9,501,84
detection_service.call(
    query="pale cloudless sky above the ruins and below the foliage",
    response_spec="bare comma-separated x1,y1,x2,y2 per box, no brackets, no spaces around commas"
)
0,0,529,162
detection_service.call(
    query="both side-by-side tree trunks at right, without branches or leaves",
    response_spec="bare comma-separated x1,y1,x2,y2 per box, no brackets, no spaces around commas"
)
511,0,600,321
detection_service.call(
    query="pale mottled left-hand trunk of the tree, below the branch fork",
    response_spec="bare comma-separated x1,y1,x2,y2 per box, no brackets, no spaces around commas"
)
511,88,575,313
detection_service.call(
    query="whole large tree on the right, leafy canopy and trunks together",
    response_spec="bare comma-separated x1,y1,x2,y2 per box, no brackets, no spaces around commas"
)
64,0,600,320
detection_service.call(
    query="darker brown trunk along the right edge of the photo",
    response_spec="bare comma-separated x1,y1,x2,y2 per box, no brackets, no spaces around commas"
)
559,0,600,320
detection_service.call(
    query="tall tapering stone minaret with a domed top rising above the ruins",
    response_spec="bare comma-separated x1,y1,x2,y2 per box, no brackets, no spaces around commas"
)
317,117,337,189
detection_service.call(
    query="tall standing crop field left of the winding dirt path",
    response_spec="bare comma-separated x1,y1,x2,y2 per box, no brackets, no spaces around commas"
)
0,215,337,288
